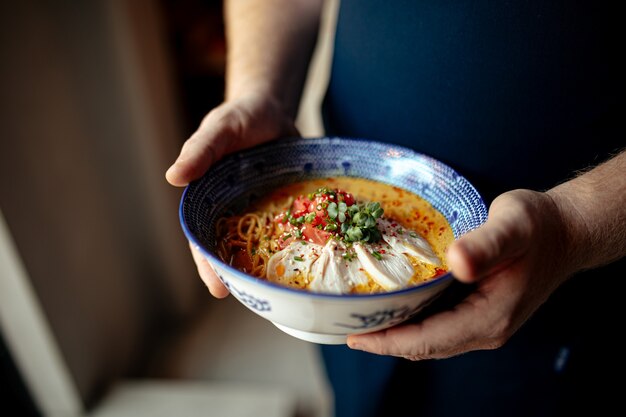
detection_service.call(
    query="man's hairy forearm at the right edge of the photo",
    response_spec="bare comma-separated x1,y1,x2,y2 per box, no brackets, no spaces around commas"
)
548,151,626,272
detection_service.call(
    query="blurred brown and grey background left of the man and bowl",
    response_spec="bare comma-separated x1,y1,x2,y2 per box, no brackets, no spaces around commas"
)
0,0,334,417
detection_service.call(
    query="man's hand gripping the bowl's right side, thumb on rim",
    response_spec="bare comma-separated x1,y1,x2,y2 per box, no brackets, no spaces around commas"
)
348,190,575,360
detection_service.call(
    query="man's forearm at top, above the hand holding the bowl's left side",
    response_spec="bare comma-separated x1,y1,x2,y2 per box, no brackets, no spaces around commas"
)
224,0,322,117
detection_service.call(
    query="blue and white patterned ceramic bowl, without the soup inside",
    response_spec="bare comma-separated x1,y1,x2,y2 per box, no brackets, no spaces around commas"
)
180,138,487,344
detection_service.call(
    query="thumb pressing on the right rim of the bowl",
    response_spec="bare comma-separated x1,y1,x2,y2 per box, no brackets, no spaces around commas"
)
447,190,533,283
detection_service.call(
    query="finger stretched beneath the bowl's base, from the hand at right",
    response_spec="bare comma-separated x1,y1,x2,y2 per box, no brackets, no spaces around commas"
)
347,290,504,360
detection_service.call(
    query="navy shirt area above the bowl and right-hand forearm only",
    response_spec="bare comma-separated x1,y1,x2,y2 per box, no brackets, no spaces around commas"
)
324,0,626,201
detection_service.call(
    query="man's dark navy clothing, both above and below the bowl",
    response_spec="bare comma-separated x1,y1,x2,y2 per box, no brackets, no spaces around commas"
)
322,0,626,417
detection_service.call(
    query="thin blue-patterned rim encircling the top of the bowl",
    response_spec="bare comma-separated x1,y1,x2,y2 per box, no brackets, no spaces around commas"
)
178,136,486,300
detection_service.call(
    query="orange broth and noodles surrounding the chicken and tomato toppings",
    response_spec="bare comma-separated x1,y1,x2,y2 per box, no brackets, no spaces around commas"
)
216,177,454,294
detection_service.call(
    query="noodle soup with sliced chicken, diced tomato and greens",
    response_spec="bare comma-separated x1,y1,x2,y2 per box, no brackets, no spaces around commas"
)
217,177,454,294
